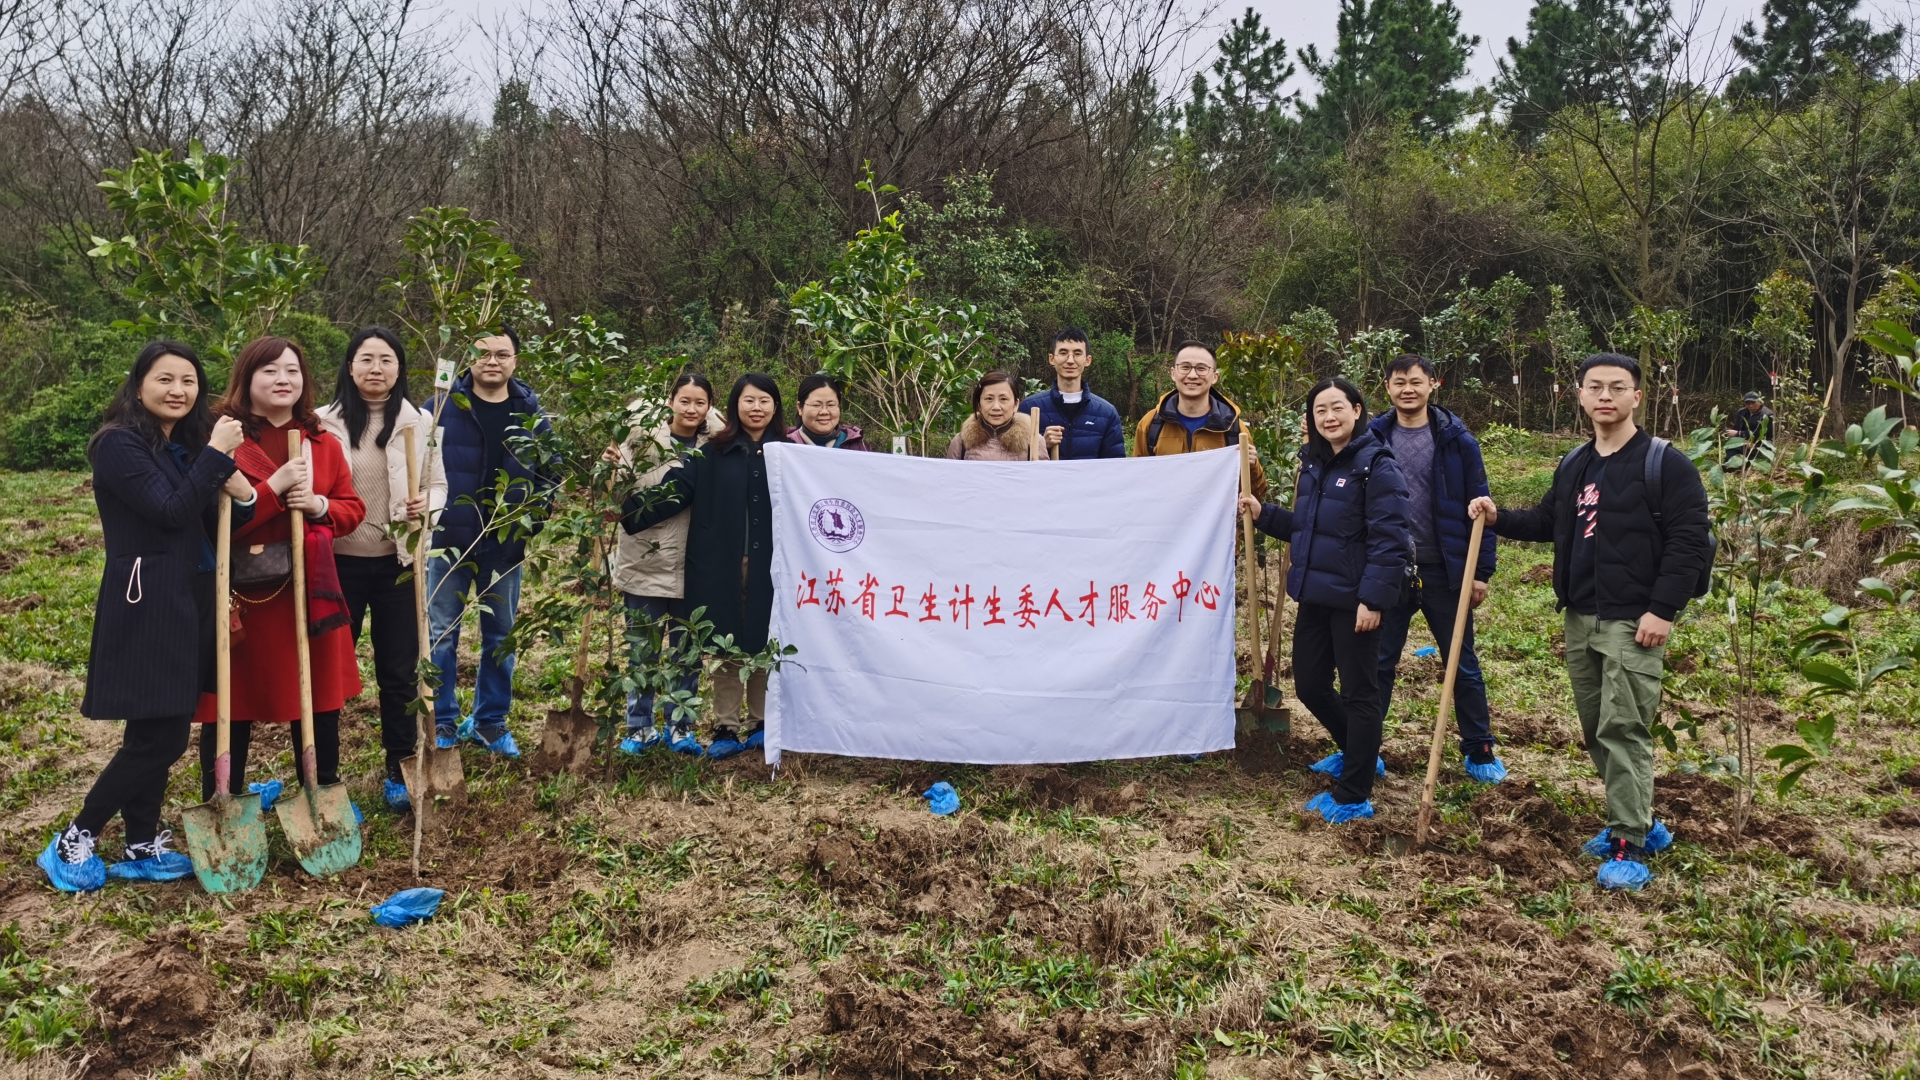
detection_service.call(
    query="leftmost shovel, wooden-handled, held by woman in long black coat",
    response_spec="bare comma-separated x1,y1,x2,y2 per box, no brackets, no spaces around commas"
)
180,494,267,892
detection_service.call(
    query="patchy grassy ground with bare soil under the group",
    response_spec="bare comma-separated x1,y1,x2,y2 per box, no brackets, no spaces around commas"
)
0,438,1920,1078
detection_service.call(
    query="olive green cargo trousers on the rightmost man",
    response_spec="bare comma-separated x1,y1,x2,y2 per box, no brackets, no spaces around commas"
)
1567,611,1667,846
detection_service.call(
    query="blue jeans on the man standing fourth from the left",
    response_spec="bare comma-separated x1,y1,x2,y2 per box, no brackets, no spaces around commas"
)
426,540,520,730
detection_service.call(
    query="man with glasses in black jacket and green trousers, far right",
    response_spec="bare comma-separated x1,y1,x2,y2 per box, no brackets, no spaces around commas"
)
1467,352,1715,888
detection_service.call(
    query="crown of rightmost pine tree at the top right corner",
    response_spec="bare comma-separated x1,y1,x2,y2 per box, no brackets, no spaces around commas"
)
1726,0,1901,104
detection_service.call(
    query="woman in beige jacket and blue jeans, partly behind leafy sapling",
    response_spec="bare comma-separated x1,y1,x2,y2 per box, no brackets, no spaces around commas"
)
612,373,726,753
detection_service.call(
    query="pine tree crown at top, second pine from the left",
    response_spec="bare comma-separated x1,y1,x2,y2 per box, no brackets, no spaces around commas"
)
1300,0,1480,150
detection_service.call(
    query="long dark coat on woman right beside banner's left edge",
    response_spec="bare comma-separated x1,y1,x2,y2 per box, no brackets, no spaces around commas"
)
620,427,781,653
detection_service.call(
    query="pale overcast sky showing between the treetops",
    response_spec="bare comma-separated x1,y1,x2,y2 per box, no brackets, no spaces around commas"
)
442,0,1920,107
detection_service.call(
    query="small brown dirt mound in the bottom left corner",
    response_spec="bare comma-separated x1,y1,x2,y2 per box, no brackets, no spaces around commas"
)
86,940,221,1076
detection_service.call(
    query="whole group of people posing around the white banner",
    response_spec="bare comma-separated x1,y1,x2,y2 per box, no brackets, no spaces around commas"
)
38,327,1713,892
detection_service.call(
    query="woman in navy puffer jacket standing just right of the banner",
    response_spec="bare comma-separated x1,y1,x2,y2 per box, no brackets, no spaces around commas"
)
1240,379,1413,822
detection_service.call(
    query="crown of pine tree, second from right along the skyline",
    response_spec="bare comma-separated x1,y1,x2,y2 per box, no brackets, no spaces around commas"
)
1494,0,1674,140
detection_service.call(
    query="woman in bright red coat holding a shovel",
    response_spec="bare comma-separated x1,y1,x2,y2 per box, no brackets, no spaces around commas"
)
194,338,367,799
